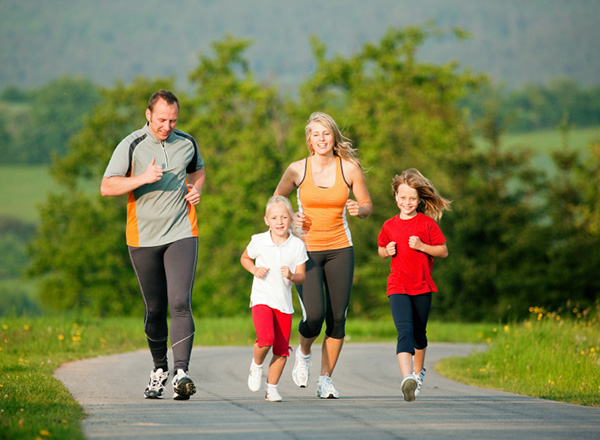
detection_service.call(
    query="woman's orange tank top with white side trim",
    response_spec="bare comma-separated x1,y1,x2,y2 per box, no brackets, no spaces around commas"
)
297,157,352,252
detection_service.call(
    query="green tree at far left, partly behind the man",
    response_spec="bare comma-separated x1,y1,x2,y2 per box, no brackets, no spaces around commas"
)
29,79,172,316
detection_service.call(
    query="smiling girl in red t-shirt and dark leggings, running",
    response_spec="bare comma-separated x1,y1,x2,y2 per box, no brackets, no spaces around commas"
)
378,168,450,402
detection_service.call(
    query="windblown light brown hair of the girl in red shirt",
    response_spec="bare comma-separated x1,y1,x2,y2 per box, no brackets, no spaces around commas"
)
392,168,452,221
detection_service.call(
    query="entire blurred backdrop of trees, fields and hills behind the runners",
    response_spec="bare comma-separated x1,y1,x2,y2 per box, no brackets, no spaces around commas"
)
0,0,600,322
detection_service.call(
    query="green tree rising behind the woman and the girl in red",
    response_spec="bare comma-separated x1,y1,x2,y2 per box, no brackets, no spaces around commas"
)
299,27,481,315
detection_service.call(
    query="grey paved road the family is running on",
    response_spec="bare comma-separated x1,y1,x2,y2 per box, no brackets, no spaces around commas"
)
55,343,600,440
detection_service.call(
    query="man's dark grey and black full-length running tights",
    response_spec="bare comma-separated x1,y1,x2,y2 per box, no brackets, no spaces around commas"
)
129,237,198,371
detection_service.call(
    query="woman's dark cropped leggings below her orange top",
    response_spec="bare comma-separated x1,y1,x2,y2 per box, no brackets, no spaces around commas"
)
296,247,354,339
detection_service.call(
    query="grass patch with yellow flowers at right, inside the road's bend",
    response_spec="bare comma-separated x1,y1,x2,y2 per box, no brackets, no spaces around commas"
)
436,303,600,407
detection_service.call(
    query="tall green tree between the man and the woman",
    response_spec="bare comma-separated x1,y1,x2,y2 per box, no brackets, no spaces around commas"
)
188,37,285,315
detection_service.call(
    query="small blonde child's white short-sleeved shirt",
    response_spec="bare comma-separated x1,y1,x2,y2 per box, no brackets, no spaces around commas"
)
246,231,308,314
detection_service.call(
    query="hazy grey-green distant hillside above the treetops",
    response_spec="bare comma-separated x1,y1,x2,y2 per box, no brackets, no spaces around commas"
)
0,0,600,93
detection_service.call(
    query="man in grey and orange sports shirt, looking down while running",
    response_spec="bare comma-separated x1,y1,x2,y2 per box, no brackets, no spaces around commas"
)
100,90,206,400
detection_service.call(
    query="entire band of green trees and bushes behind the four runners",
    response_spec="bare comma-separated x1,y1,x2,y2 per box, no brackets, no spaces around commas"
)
31,26,600,321
